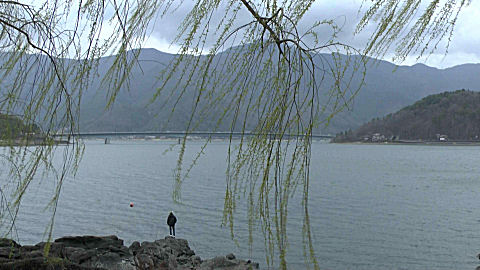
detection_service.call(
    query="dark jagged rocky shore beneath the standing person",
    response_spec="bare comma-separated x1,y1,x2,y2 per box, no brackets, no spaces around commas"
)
0,235,258,270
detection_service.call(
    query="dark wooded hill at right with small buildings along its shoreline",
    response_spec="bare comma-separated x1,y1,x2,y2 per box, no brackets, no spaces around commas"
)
334,90,480,142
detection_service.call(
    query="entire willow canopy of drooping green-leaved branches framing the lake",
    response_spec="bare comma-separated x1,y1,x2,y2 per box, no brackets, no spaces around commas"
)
0,0,470,269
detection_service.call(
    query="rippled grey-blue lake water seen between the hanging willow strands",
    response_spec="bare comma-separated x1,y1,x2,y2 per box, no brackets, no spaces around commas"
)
1,140,480,269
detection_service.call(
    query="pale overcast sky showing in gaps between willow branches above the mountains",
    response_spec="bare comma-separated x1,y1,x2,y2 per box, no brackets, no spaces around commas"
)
144,0,480,68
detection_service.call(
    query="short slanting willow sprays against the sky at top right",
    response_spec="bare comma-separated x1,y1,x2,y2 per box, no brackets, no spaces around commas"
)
355,0,471,62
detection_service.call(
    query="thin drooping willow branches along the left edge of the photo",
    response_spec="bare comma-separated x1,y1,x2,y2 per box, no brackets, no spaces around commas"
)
0,0,156,251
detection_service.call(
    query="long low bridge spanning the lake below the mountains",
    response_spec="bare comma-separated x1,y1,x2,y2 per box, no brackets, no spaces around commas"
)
53,131,334,139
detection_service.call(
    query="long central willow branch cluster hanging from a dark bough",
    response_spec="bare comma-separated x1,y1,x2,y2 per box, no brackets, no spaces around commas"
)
155,0,365,269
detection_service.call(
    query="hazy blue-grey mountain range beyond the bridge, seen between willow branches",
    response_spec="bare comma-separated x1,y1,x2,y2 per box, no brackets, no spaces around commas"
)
1,47,480,134
